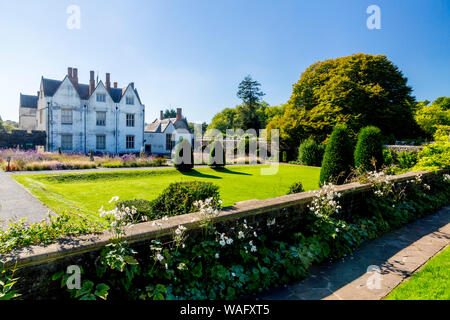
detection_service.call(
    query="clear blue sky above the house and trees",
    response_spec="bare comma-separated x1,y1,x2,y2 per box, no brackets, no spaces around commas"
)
0,0,450,122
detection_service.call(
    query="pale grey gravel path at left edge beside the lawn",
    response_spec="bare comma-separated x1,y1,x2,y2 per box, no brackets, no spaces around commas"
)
0,170,49,227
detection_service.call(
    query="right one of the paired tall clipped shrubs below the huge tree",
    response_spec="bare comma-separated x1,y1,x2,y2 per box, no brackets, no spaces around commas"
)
355,126,383,172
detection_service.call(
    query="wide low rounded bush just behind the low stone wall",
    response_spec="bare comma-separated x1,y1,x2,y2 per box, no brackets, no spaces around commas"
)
149,181,220,220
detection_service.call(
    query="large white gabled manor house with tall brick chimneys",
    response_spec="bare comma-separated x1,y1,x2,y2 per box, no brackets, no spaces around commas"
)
19,68,145,154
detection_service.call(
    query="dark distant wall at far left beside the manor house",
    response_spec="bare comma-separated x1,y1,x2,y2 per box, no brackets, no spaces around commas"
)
0,130,46,149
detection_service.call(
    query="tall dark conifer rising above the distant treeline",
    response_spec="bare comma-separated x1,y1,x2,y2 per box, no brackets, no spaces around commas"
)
236,75,264,130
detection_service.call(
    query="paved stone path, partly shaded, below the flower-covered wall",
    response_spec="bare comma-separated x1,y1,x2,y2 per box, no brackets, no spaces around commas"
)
259,207,450,300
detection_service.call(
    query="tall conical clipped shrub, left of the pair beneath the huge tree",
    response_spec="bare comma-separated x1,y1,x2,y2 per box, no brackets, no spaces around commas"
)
320,125,353,184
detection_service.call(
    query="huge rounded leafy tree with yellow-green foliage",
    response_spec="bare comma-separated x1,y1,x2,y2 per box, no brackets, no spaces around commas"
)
267,53,418,157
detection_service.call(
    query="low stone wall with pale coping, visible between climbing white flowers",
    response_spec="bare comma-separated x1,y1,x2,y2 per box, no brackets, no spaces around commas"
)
7,172,442,299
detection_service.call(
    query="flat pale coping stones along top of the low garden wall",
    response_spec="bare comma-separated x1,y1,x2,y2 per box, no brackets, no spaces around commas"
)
5,171,434,268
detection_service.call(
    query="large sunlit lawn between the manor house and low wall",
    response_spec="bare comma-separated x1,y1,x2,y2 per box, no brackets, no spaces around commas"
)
13,165,320,222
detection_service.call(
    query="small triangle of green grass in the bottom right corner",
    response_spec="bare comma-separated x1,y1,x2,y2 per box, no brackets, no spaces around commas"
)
386,247,450,300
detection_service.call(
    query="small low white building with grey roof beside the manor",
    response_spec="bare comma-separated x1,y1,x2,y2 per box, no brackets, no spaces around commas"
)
144,108,193,155
